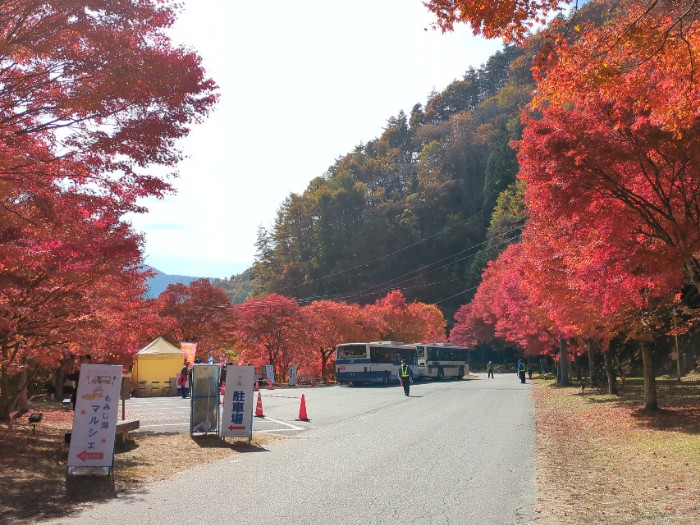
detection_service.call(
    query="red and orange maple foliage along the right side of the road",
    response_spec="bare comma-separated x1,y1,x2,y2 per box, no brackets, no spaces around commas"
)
447,2,700,409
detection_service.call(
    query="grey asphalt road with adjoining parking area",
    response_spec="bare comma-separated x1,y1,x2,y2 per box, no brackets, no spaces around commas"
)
45,374,536,525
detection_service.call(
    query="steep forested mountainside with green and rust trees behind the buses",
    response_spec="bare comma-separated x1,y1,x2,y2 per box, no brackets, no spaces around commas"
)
254,36,535,318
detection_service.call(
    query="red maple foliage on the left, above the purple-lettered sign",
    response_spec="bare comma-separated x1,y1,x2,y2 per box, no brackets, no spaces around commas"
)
0,0,216,417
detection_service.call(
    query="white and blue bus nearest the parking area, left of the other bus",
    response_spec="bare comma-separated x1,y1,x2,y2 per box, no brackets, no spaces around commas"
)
335,341,420,385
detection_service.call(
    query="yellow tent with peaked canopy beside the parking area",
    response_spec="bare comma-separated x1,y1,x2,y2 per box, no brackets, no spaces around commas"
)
131,337,184,397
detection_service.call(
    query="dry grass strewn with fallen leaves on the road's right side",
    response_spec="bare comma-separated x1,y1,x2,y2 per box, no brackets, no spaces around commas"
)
534,377,700,525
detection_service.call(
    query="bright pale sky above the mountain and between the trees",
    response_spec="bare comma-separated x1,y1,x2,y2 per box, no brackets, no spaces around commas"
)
129,0,502,277
